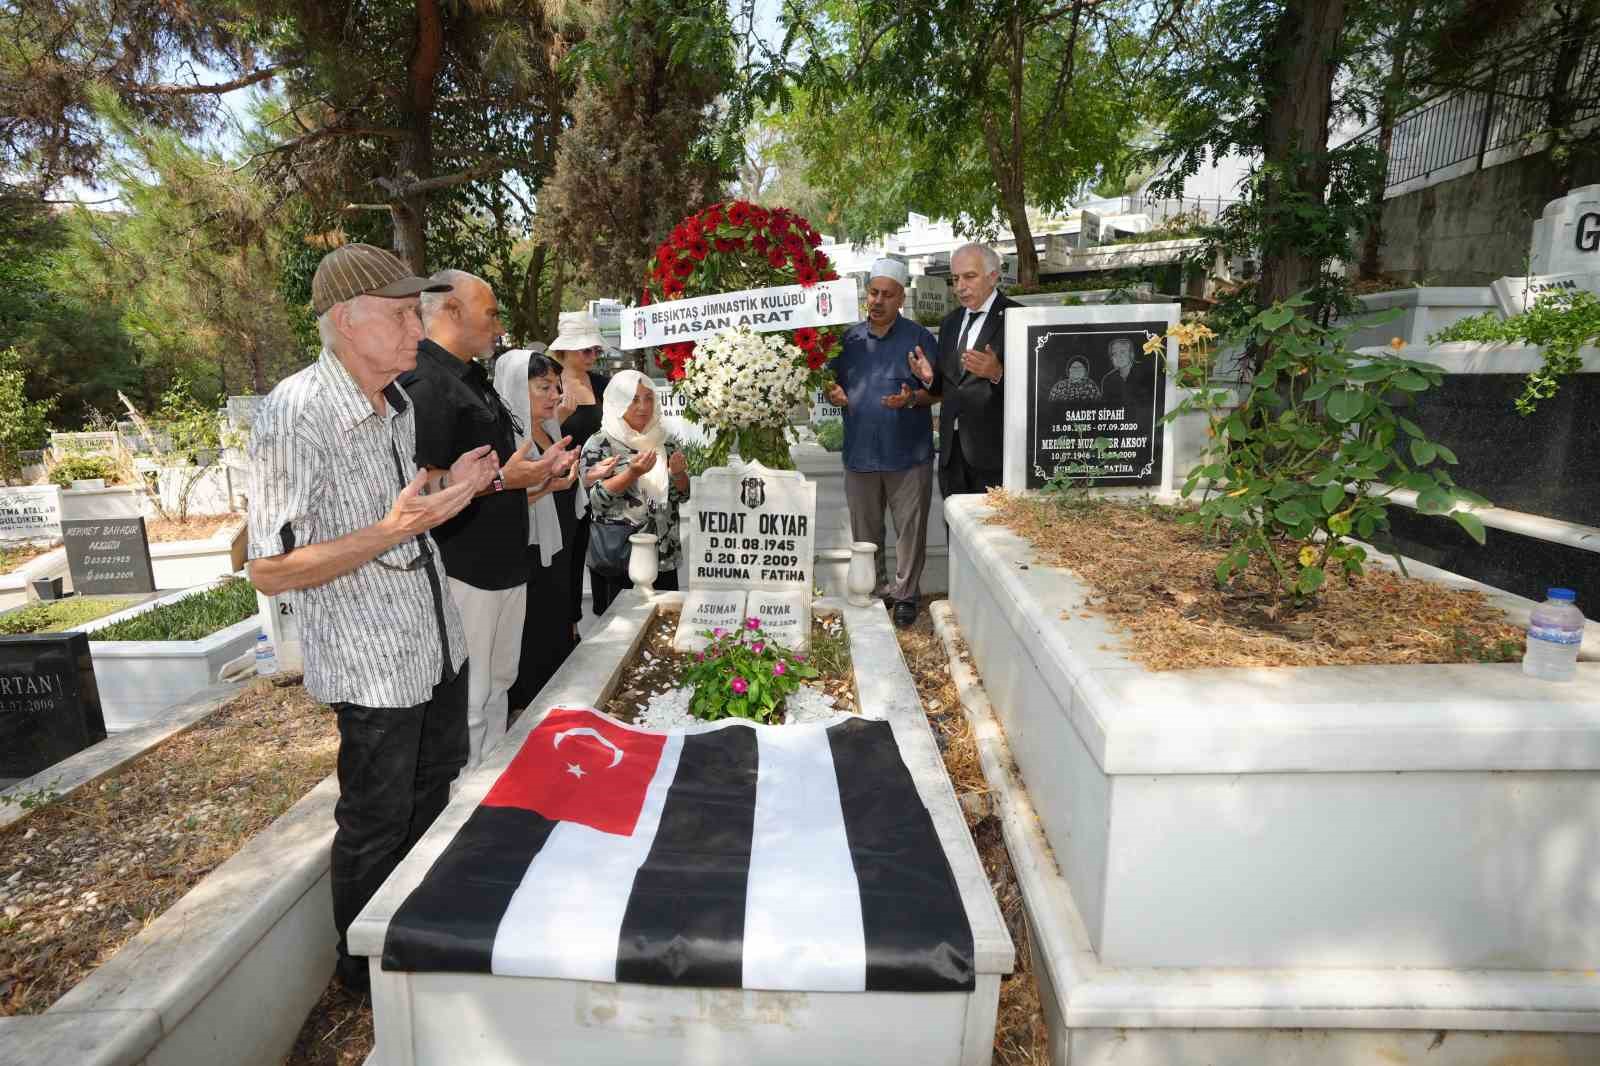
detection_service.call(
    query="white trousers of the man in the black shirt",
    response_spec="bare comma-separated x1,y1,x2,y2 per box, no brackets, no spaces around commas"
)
450,578,528,770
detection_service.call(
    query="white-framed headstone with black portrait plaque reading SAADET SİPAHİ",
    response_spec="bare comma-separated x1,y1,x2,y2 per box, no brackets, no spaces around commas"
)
1003,304,1179,491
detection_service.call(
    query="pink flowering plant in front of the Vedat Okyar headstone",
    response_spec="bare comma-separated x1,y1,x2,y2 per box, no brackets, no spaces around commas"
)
678,618,818,722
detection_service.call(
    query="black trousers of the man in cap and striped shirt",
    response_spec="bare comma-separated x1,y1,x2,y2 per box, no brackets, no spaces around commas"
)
330,664,469,986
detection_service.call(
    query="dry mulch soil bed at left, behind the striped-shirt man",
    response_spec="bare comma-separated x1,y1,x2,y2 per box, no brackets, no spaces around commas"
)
0,677,339,1015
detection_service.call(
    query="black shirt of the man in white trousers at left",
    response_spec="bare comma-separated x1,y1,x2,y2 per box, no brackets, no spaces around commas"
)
400,339,528,589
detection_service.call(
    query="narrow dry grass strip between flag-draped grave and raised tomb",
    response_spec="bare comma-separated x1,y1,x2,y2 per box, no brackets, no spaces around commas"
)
898,597,1050,1066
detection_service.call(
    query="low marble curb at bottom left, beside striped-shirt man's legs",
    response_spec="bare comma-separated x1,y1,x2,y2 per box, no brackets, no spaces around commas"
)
0,776,339,1066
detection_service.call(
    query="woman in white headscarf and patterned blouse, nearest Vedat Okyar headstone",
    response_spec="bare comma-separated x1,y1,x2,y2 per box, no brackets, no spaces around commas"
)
578,370,690,615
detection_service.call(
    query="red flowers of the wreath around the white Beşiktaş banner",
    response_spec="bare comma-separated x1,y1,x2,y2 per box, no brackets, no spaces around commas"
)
640,200,843,386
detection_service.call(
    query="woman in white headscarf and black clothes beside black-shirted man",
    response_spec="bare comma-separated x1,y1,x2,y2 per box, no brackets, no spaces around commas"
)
494,351,584,711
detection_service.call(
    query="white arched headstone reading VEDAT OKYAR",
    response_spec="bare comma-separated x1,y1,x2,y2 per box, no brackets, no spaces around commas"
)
688,463,816,595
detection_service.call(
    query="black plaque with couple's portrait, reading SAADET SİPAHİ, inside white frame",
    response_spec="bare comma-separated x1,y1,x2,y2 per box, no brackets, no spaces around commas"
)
1027,322,1166,488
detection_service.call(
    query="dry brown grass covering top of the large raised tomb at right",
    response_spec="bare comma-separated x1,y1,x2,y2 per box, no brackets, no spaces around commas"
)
989,491,1523,671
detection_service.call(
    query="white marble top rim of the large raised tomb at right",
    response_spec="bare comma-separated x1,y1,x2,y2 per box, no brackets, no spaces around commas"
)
946,496,1600,775
